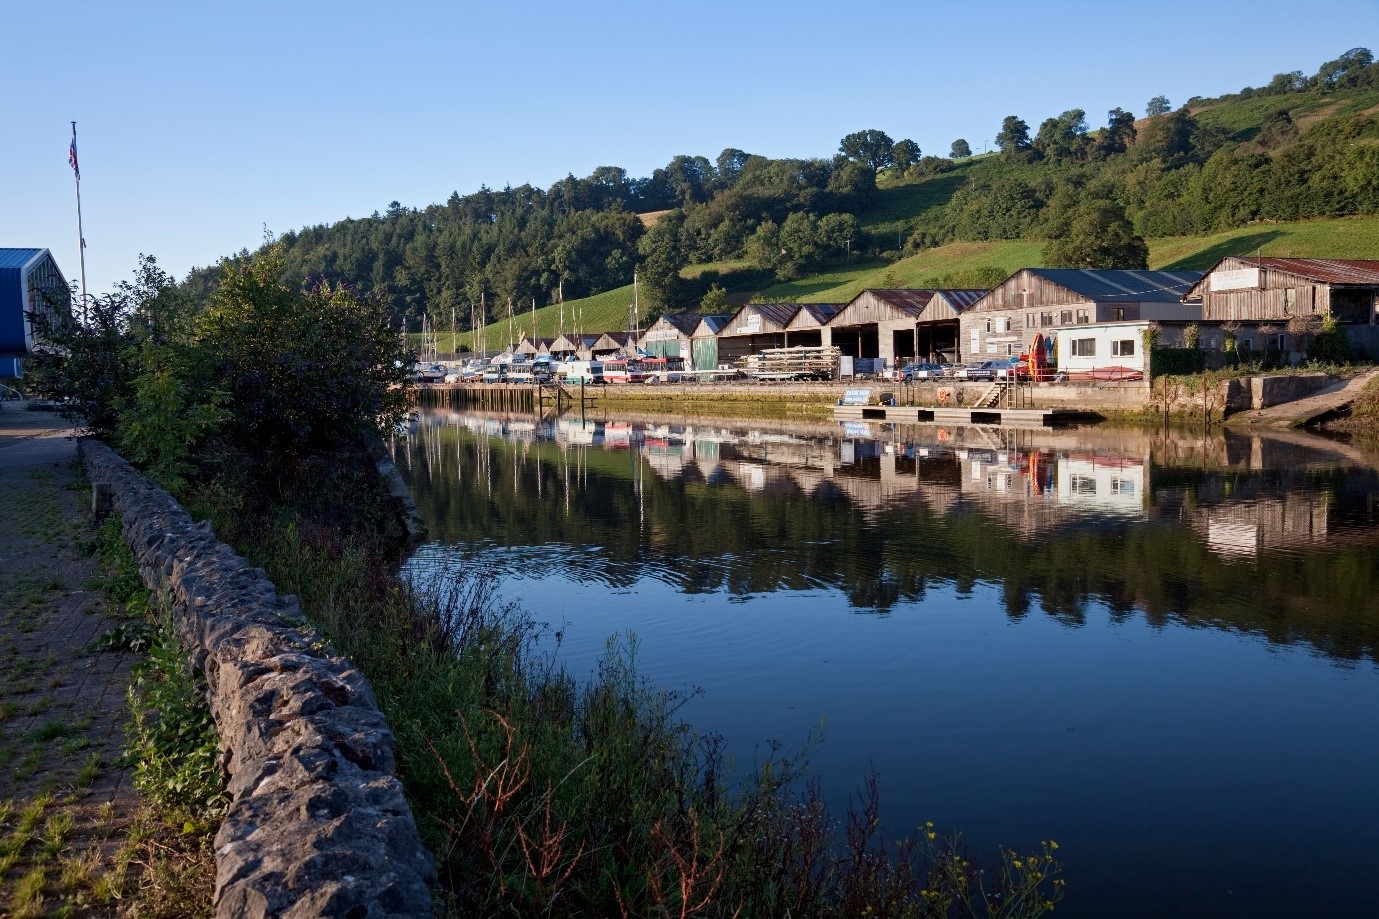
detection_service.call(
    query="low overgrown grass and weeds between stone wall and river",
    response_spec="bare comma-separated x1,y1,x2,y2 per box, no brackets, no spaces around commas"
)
175,460,1062,918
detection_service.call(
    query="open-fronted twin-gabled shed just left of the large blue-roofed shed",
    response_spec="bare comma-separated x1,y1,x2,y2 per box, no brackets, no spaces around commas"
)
823,288,987,367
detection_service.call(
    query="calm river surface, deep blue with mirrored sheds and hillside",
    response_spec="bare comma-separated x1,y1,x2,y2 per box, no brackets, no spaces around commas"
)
394,411,1379,916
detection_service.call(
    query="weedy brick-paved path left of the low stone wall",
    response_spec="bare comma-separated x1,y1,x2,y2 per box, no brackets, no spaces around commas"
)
0,410,138,916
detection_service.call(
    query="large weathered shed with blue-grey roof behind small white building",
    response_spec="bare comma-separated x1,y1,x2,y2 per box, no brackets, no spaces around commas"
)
957,268,1202,362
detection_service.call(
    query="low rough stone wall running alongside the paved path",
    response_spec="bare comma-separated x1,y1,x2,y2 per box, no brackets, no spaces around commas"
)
81,439,436,919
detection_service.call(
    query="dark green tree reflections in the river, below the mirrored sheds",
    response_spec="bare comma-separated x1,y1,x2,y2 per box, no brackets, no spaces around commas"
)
400,429,1379,660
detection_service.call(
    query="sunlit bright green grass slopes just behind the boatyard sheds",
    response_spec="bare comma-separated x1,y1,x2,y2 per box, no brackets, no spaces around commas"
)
435,215,1379,352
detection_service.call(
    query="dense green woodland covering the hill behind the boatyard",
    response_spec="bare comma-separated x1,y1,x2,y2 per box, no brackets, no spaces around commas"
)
188,48,1379,321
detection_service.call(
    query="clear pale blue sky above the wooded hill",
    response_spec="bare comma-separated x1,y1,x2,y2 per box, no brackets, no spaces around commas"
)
0,0,1379,293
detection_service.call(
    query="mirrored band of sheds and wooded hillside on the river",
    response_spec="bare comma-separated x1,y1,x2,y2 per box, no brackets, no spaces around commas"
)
394,411,1379,658
